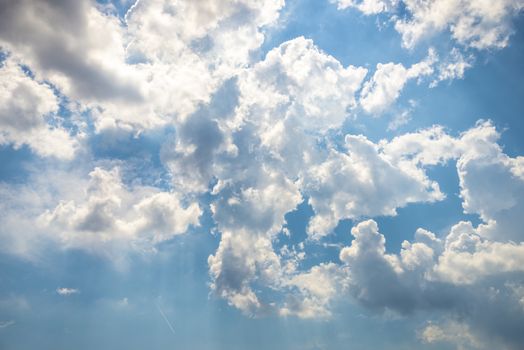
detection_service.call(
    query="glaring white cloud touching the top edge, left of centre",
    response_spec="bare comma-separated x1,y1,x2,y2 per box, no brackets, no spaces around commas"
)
93,0,284,129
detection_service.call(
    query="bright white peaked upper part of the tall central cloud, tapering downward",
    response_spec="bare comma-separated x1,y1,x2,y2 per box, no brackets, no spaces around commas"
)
232,37,366,178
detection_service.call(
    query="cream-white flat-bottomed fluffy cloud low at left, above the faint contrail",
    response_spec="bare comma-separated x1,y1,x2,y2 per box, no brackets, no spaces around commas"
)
38,168,202,251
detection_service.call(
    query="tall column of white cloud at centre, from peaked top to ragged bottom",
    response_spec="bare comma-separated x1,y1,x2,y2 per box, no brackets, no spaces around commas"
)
180,38,366,317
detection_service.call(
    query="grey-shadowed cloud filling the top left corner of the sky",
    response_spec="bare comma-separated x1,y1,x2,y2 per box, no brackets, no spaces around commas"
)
0,0,140,100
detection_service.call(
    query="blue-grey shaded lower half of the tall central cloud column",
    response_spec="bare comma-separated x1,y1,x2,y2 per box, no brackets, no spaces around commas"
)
208,168,301,314
